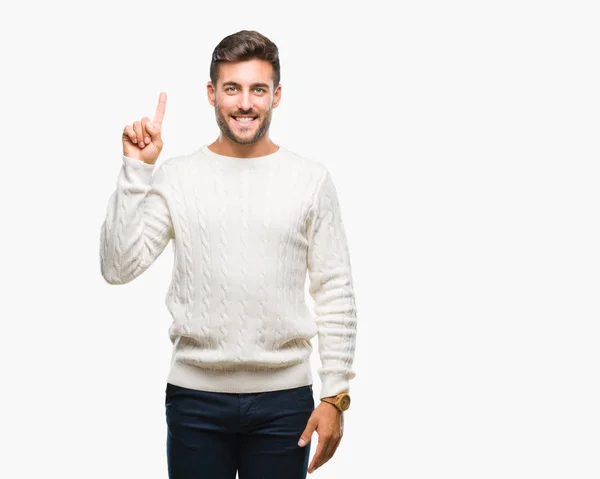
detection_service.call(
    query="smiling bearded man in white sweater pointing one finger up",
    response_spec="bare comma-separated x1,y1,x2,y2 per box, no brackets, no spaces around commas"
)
100,31,356,479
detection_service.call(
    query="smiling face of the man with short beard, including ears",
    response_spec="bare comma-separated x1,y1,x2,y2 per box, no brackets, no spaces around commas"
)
207,59,281,145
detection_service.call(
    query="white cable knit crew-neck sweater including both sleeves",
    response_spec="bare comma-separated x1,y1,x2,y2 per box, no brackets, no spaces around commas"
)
100,145,356,397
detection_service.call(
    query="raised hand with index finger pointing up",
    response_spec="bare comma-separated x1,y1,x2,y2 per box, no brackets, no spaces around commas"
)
122,92,167,165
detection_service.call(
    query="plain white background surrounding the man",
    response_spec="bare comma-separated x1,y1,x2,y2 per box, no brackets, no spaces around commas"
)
0,0,600,479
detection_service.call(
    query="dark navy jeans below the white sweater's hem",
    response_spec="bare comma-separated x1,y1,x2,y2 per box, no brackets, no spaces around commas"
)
165,383,315,479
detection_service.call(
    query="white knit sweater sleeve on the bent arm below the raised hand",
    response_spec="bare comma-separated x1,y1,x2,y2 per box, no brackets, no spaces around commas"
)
100,155,175,284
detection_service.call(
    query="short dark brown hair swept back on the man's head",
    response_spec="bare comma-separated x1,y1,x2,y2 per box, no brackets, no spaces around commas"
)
210,30,281,89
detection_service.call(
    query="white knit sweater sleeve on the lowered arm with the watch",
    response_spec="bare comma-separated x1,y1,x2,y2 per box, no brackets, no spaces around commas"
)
307,171,356,398
